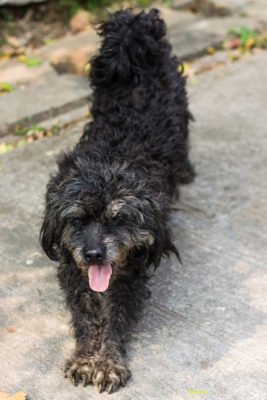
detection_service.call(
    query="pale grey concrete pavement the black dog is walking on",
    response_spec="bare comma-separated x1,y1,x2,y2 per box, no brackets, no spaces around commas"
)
0,10,267,400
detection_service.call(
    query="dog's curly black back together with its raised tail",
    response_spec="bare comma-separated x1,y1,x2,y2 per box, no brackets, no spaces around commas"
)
80,9,194,195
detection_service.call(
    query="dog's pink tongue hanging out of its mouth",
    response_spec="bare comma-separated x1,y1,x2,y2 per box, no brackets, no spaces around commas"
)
88,264,112,292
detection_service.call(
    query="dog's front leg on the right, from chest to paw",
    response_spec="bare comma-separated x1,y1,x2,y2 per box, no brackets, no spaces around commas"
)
92,281,148,393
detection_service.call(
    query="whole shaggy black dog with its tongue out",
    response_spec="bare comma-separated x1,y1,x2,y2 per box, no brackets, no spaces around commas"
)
40,9,194,393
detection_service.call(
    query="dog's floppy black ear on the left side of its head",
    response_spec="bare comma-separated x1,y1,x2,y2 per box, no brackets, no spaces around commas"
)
40,195,62,261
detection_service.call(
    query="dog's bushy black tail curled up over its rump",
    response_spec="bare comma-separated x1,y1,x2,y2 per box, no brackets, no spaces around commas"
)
90,9,178,90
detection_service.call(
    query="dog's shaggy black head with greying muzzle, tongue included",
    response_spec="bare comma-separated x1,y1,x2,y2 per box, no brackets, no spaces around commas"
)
40,155,177,291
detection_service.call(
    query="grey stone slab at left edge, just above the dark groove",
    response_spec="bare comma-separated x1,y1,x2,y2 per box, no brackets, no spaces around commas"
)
0,73,90,136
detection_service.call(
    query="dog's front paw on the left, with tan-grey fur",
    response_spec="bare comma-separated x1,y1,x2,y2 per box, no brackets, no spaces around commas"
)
64,357,94,386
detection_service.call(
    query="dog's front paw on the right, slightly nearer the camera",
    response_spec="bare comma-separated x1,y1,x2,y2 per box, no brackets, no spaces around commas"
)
92,360,130,393
